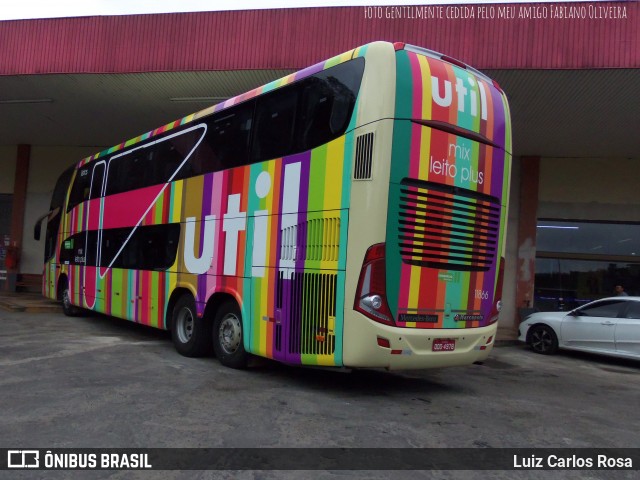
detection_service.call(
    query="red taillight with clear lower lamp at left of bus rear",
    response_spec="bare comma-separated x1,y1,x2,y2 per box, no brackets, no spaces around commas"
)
353,243,395,325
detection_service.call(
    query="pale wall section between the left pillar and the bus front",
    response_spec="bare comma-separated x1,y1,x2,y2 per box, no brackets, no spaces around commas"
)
20,147,102,274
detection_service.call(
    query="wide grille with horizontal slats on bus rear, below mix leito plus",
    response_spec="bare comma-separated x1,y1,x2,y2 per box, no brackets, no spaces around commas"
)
398,179,500,271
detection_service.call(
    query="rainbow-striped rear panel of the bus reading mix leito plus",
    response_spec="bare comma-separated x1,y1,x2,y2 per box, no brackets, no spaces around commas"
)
387,51,511,328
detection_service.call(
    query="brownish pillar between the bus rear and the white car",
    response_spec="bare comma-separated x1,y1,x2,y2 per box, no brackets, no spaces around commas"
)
516,157,540,321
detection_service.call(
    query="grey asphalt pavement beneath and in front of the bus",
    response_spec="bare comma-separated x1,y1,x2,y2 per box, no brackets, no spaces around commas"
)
0,300,640,478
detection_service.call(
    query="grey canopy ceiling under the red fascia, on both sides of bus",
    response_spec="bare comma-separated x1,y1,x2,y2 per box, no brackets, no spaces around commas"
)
0,69,640,157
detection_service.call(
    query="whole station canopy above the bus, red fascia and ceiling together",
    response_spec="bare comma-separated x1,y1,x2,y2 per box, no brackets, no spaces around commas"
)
0,2,640,158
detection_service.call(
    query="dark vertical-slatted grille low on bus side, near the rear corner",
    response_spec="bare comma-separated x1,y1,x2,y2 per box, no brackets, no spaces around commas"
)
288,272,338,355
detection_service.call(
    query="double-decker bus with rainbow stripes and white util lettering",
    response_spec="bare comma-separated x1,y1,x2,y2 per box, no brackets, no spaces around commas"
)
37,42,511,369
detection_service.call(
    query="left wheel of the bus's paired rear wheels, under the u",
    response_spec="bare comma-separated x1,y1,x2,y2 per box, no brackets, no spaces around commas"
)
171,294,211,357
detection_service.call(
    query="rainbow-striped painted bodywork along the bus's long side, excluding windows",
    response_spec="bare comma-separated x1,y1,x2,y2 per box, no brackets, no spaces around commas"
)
44,48,357,365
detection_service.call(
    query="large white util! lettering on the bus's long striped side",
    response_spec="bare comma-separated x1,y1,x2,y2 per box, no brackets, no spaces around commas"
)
183,162,301,277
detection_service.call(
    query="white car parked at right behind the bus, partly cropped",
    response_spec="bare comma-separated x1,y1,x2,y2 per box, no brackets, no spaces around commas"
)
518,297,640,359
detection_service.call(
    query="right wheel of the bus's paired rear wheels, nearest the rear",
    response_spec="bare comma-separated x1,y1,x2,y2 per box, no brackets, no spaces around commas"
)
213,300,249,368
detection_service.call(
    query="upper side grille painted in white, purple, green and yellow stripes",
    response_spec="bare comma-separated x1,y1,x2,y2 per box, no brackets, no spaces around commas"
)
280,217,340,262
